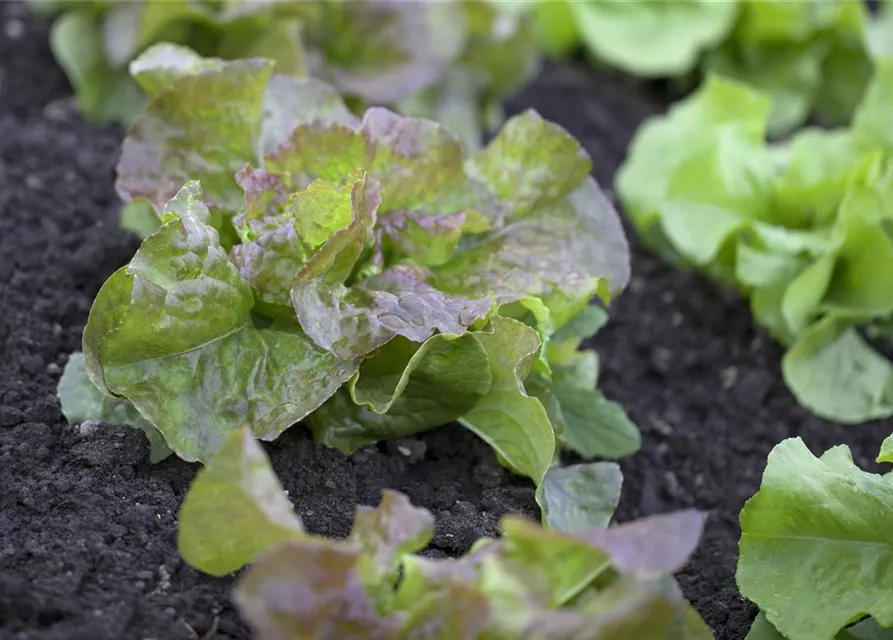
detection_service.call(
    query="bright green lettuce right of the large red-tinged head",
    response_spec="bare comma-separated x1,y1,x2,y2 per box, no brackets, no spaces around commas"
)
616,61,893,423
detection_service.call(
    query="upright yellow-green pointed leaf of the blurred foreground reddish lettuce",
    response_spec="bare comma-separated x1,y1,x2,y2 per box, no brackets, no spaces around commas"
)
177,427,305,576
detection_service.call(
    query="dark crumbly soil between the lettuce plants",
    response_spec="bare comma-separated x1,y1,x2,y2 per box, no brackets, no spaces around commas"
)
0,2,890,640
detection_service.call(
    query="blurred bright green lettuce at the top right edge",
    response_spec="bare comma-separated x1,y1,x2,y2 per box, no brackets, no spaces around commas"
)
535,0,876,133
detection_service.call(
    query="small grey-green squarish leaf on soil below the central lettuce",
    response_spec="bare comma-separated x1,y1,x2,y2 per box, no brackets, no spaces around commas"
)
537,462,623,533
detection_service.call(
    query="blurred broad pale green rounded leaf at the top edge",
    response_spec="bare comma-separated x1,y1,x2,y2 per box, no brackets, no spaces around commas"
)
569,0,739,77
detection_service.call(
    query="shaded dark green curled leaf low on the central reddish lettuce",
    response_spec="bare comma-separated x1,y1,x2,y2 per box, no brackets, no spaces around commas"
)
307,333,493,453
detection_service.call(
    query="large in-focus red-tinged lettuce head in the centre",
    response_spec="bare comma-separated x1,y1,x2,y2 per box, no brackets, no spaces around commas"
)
60,45,639,502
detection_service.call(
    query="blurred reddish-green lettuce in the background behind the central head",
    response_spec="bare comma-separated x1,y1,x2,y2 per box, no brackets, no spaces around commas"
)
29,0,538,147
